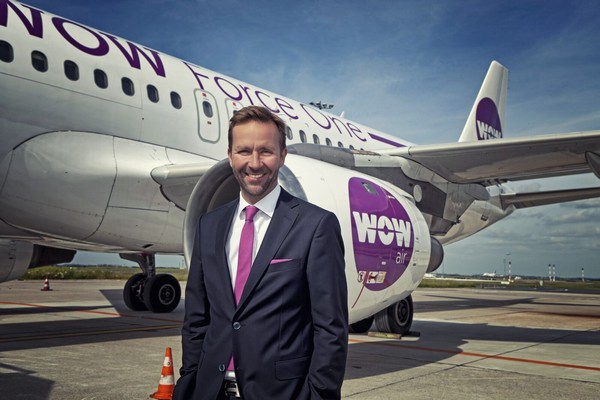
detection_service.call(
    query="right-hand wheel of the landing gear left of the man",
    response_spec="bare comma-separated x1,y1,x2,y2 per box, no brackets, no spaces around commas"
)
144,274,181,313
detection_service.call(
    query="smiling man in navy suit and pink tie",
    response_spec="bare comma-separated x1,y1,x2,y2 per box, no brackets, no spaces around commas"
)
174,106,348,400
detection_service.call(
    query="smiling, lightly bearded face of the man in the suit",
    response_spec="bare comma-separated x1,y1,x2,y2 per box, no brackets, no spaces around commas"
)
227,121,287,204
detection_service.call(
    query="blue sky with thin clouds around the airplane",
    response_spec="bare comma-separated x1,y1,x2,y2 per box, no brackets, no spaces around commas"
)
17,0,600,278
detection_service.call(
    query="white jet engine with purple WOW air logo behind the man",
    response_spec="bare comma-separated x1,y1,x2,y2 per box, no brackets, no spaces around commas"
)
184,154,443,332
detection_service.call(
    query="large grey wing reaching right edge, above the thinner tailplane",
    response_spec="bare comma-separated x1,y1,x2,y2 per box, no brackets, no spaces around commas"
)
382,131,600,184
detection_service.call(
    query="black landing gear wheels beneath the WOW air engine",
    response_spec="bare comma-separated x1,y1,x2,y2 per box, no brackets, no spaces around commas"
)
350,296,414,335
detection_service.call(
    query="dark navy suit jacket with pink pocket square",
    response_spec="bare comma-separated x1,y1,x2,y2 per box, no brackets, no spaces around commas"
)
174,190,348,400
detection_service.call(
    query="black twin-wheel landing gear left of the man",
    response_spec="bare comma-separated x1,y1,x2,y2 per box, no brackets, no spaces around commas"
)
120,253,181,313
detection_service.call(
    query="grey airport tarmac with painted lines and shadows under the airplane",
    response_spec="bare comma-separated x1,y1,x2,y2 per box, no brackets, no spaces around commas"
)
0,281,600,400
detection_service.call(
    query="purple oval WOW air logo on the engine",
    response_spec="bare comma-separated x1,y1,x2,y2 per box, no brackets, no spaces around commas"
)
348,178,414,291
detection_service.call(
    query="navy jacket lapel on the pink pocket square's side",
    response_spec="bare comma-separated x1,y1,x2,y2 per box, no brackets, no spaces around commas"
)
238,189,298,310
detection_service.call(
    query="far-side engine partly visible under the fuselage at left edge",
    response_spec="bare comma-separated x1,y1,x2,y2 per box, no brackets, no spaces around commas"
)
0,239,75,282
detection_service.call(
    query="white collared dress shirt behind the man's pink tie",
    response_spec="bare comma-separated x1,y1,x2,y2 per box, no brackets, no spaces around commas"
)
225,185,281,288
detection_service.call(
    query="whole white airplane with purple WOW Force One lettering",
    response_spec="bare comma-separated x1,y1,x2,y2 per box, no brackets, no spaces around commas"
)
0,0,600,333
